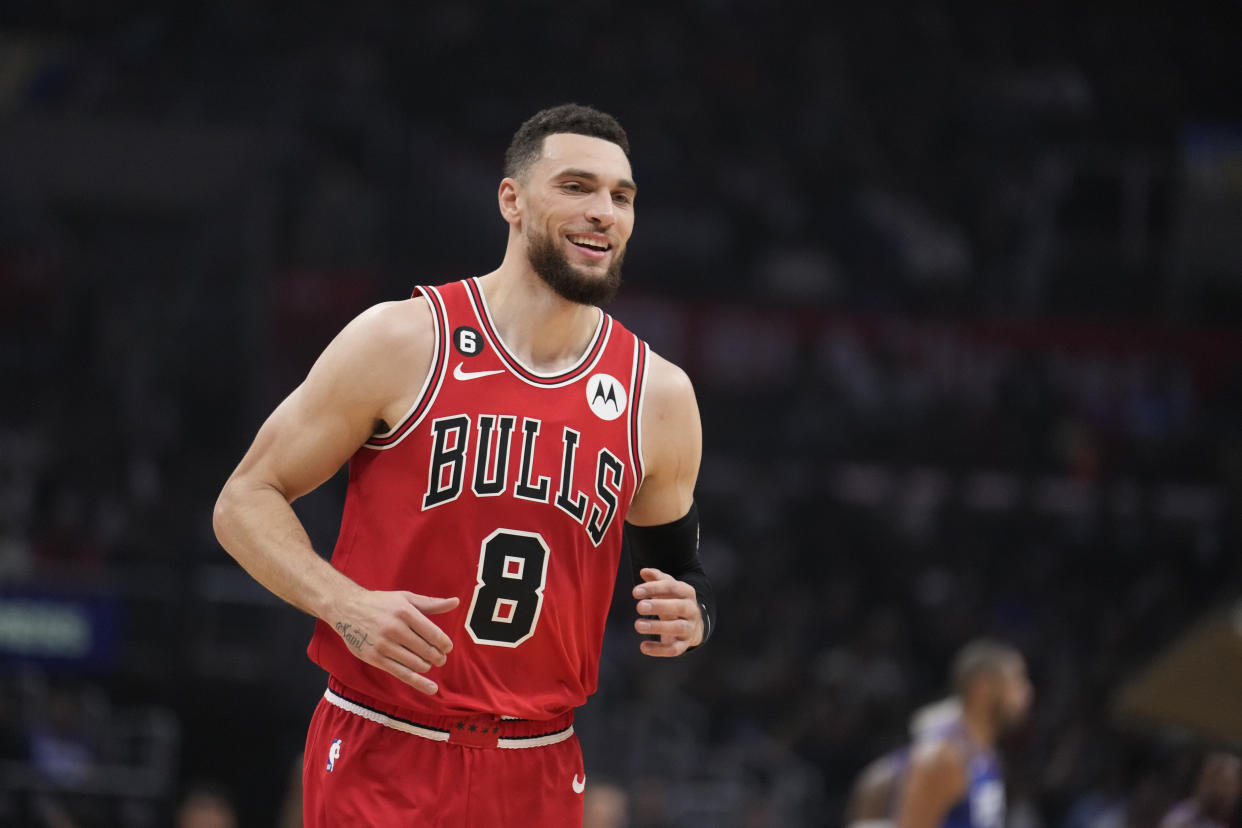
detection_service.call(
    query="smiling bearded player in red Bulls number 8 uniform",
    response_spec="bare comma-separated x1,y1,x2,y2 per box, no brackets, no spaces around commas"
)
215,104,714,828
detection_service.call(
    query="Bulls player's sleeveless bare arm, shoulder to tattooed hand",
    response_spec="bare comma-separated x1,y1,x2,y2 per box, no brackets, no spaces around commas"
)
212,299,457,693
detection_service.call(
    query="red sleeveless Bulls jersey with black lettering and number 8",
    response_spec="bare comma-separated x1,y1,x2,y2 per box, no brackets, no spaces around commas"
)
309,279,648,719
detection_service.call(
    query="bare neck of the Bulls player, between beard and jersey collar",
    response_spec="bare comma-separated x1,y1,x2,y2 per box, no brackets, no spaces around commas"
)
479,245,600,374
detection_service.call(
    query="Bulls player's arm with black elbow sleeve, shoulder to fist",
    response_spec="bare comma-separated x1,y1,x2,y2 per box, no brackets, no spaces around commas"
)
626,354,715,658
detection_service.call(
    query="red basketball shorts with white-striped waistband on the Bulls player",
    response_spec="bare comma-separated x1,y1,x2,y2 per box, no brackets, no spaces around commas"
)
302,682,586,828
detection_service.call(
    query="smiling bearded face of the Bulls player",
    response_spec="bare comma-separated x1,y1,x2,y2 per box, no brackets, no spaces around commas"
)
519,133,637,304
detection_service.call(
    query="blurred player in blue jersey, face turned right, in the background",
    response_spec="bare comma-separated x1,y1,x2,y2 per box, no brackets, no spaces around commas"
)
897,639,1031,828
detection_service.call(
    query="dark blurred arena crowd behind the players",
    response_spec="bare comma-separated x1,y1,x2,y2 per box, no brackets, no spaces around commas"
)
0,0,1242,828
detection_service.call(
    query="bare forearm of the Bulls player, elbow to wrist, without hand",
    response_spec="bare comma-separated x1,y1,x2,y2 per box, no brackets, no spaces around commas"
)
212,478,361,623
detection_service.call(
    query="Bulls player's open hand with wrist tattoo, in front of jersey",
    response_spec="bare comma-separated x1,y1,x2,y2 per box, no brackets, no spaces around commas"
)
333,590,458,695
